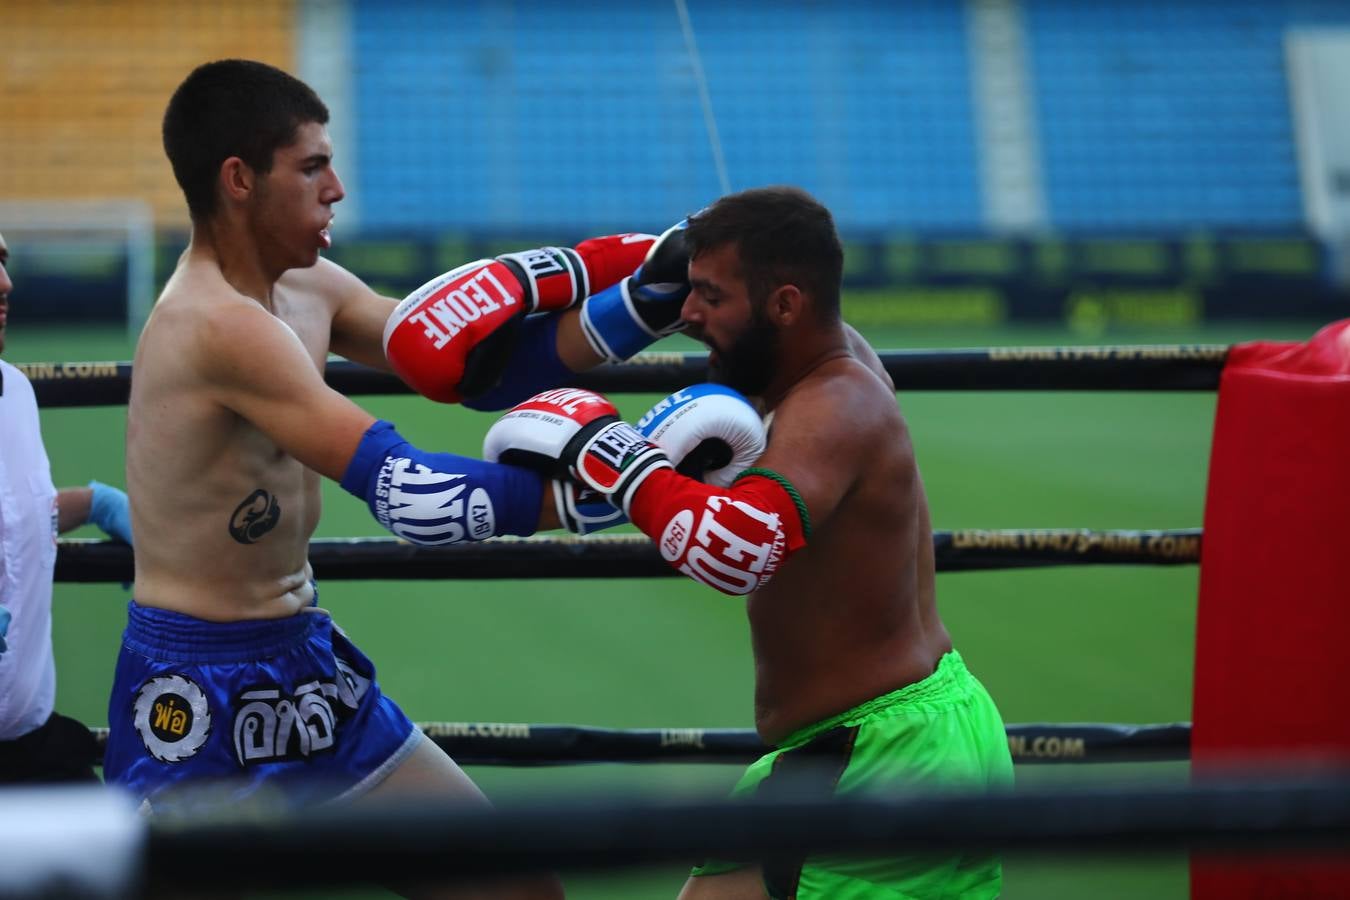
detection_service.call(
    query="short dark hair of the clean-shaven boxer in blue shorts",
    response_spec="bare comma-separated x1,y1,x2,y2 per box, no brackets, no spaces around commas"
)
162,59,328,221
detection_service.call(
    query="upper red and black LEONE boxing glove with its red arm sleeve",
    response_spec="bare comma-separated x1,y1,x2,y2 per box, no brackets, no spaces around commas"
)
383,233,656,403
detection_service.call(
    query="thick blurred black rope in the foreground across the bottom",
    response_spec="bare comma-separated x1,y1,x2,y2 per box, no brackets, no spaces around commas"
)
144,772,1350,892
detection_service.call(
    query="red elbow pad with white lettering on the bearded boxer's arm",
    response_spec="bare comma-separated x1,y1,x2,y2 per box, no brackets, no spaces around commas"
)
629,470,806,594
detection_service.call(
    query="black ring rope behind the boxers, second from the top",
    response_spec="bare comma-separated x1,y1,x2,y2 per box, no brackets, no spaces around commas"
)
55,529,1200,582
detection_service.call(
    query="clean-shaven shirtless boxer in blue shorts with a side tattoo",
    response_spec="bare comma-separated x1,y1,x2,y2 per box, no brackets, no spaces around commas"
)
104,59,687,896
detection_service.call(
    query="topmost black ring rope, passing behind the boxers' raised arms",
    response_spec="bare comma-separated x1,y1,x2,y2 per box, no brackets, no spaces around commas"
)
16,344,1229,409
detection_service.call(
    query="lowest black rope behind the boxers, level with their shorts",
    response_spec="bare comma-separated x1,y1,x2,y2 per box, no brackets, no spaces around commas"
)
89,722,1191,766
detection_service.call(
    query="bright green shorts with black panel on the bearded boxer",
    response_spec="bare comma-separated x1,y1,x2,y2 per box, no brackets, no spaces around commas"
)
694,650,1013,900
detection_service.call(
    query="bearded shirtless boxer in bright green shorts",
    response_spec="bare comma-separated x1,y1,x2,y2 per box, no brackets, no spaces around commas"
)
485,188,1013,900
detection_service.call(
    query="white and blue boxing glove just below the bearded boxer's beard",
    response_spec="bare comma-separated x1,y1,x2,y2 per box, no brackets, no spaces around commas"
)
494,385,767,534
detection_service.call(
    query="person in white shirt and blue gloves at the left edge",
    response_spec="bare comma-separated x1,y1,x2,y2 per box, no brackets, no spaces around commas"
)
0,235,131,783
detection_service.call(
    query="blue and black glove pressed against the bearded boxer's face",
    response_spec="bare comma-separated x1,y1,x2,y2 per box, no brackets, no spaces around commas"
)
581,220,690,363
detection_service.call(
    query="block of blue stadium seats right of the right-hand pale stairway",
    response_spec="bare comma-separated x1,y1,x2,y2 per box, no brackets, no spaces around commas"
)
1023,0,1350,229
